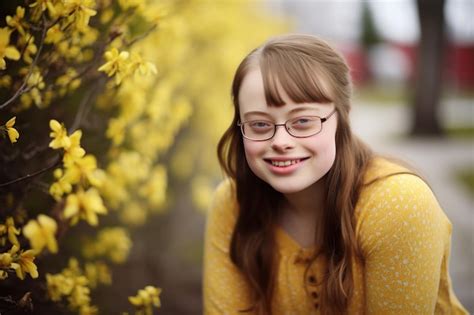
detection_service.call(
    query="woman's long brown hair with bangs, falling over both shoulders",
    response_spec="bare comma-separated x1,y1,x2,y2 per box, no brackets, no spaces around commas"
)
217,34,373,314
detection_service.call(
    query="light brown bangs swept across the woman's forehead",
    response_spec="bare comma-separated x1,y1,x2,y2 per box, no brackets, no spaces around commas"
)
259,46,334,106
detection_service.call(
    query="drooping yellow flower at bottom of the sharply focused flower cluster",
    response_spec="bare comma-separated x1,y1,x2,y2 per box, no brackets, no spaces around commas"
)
64,188,107,226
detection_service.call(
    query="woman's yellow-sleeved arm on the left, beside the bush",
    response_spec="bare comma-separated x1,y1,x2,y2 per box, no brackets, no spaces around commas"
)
203,181,256,315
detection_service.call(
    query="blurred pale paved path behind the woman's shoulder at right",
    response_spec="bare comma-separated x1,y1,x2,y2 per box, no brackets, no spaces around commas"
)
351,102,474,313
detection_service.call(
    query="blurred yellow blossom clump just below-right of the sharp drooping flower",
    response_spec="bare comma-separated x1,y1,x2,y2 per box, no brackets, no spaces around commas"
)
83,227,132,264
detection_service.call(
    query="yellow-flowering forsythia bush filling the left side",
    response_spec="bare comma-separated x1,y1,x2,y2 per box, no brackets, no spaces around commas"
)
0,0,284,314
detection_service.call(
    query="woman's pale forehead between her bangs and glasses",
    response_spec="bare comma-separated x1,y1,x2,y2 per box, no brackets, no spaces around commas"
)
238,67,329,119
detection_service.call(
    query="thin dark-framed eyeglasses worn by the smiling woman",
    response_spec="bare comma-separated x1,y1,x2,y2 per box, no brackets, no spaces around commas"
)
237,110,336,141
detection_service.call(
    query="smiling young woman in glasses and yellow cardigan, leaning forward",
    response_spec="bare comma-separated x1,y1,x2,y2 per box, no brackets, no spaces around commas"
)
204,35,467,315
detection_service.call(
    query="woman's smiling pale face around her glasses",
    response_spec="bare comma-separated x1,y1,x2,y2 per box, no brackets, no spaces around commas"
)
238,67,337,194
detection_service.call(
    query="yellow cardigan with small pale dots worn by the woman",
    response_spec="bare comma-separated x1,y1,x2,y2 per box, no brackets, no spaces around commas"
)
203,158,467,315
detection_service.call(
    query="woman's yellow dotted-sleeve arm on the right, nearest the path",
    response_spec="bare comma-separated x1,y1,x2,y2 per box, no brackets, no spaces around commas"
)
358,175,451,314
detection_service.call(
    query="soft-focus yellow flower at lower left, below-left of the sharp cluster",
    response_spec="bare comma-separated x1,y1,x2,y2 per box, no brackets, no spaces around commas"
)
23,214,58,253
